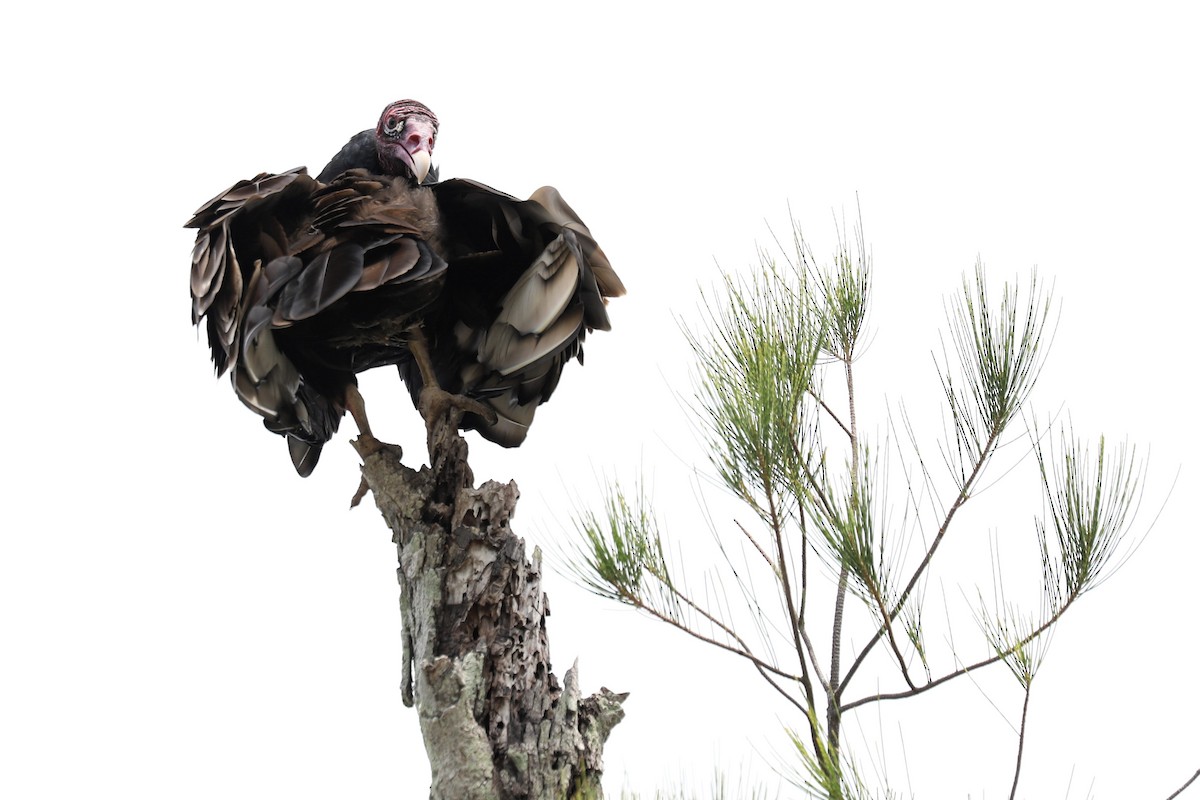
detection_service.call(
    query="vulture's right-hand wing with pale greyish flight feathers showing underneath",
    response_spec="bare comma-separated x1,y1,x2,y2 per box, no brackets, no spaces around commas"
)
402,180,625,446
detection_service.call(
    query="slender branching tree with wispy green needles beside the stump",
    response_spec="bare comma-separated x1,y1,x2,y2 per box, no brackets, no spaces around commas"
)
574,209,1141,800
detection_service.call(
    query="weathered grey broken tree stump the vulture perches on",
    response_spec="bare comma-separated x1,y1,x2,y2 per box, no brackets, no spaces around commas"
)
355,414,628,800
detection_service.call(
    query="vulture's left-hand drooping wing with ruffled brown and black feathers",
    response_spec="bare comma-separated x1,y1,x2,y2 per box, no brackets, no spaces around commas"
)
187,168,446,475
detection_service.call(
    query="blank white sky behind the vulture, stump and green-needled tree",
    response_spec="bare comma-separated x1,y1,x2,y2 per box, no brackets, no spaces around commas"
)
0,2,1200,798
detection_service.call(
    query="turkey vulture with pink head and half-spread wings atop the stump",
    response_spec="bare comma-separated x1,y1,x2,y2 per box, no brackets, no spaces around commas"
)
186,101,625,476
